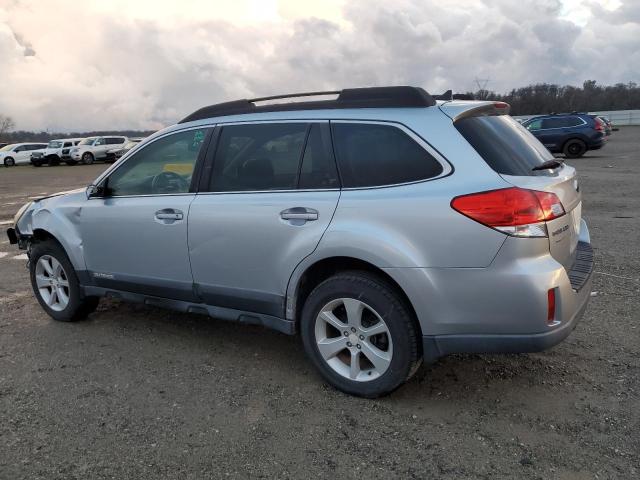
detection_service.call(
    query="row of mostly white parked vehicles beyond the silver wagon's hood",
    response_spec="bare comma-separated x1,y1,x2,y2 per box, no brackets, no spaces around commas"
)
0,135,142,167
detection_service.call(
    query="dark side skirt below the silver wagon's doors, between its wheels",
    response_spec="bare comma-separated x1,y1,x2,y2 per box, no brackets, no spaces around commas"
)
81,285,296,335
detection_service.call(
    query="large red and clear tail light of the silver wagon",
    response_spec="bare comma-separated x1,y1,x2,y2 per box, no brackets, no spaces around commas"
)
451,187,565,237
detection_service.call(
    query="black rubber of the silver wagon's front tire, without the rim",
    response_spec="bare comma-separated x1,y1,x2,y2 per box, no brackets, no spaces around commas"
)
29,240,90,322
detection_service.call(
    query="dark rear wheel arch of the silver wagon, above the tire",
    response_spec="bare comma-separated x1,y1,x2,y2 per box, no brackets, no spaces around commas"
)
286,256,421,338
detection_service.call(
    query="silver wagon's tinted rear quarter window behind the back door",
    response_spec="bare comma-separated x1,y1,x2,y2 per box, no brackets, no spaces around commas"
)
332,122,443,188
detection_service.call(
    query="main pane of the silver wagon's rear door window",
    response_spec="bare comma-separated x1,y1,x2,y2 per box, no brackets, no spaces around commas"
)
210,123,309,192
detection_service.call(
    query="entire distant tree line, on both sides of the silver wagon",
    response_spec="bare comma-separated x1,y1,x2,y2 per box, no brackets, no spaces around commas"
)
0,80,640,143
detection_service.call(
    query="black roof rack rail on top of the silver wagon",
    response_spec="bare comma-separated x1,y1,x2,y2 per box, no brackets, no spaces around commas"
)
178,86,436,123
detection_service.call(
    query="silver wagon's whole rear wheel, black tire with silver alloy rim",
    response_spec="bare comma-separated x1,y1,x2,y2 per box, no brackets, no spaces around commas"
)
300,271,422,398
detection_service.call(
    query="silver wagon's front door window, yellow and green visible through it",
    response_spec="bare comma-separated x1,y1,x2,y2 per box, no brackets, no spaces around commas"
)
106,128,208,197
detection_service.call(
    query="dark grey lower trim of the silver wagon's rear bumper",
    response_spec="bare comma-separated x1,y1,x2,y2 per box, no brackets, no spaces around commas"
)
422,242,594,362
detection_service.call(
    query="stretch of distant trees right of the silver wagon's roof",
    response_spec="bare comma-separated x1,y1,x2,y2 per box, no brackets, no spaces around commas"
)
465,80,640,115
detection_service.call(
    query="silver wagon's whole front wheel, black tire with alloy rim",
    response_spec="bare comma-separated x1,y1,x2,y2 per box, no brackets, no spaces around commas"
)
29,240,99,322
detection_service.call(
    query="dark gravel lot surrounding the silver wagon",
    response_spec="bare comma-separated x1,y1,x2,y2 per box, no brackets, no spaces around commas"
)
0,127,640,480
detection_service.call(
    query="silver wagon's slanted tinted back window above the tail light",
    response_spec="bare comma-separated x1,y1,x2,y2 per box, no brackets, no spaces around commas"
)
454,115,553,176
